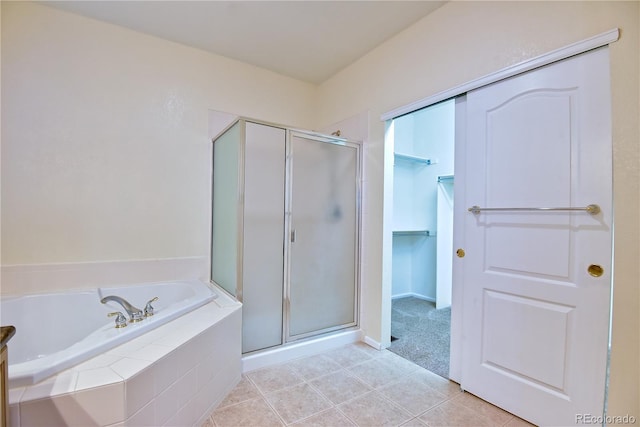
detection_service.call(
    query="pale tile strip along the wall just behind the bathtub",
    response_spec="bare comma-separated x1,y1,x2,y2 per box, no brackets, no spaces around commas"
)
0,257,209,296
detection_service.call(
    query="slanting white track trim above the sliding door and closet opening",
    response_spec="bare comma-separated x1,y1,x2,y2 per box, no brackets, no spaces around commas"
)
380,28,620,121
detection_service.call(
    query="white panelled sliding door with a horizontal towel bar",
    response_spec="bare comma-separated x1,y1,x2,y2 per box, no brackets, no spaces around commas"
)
458,48,612,425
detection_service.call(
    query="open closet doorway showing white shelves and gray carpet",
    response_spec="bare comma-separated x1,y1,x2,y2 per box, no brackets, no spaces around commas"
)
389,99,456,378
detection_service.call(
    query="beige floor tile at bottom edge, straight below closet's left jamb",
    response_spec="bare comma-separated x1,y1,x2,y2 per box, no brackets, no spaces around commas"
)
338,391,413,427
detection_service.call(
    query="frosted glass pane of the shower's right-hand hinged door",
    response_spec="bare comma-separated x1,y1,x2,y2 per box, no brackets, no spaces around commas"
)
286,132,359,341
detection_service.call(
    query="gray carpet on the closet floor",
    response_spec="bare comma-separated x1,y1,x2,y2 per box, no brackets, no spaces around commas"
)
388,297,451,378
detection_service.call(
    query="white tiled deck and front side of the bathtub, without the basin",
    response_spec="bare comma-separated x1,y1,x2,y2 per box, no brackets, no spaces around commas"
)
9,296,242,427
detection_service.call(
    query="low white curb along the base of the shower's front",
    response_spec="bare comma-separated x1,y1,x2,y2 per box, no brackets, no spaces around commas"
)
242,329,362,372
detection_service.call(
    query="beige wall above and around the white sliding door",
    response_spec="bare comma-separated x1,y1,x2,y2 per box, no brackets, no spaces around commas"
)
318,1,640,418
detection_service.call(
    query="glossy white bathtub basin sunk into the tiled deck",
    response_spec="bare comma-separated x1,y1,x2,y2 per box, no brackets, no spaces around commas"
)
0,281,216,387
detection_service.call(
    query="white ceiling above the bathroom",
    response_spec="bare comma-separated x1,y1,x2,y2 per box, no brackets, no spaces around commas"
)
44,0,444,83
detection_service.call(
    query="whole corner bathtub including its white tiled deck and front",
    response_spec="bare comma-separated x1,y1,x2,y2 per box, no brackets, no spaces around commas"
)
1,281,241,426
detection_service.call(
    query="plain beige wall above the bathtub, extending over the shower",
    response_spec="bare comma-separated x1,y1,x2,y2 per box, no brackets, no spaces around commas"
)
2,1,317,266
